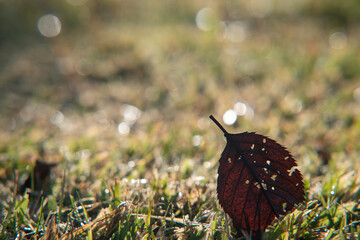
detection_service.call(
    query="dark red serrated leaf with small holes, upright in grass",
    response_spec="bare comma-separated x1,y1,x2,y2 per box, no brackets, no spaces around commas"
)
210,115,304,239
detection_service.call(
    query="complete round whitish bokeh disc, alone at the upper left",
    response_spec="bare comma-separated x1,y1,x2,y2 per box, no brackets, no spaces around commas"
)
37,14,61,38
